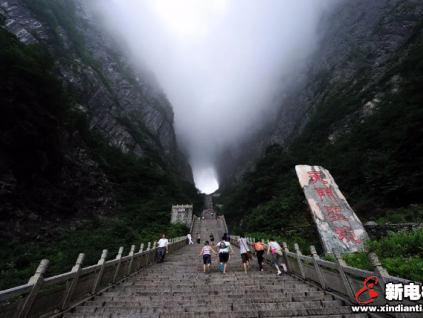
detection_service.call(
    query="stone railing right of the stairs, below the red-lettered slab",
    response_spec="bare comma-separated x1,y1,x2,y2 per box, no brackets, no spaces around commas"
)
222,211,423,318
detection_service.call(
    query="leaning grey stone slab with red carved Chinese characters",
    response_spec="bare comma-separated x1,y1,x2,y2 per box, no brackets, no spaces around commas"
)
295,165,369,253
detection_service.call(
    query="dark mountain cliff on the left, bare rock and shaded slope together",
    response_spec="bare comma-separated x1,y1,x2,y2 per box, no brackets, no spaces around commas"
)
0,0,198,240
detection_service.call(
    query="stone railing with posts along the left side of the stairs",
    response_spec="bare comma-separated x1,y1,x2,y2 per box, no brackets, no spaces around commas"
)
0,236,187,318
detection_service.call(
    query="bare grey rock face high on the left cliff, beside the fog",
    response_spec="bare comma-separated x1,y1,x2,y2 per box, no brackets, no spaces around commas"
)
0,0,193,182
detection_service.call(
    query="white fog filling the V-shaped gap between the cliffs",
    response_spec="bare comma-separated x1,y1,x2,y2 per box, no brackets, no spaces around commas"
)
93,0,333,193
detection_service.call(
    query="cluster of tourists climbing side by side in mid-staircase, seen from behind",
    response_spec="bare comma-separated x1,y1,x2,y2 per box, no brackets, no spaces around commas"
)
199,233,286,275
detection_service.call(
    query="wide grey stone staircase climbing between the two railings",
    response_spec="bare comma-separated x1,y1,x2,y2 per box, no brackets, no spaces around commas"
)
63,216,369,318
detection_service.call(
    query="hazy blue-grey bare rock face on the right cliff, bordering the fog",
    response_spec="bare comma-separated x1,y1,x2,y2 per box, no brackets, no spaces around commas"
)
218,0,423,189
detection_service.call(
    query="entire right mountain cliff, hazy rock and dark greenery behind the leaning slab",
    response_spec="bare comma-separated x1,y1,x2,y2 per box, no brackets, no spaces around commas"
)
218,0,423,233
